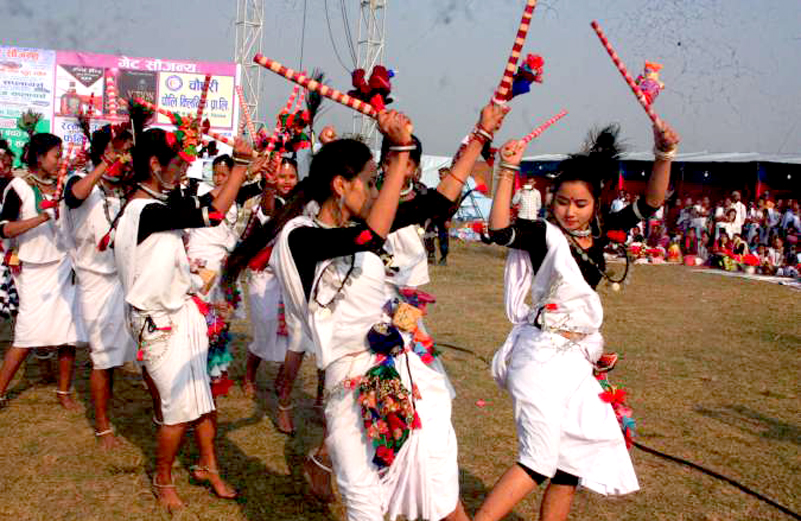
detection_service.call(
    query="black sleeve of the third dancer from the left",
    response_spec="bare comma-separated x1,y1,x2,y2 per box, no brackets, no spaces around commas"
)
137,191,220,244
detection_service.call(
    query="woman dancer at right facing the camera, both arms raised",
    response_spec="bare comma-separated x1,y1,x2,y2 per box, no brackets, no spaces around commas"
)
475,122,678,521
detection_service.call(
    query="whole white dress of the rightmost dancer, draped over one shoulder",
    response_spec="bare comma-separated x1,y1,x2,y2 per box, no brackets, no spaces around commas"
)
492,223,639,495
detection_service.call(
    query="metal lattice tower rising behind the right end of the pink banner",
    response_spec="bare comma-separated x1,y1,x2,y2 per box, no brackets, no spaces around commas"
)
234,0,264,129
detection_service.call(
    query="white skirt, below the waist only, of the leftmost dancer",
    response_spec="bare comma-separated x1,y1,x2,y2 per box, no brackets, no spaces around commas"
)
14,256,86,348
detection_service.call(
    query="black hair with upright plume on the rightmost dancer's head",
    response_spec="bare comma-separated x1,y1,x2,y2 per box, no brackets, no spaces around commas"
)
553,125,623,201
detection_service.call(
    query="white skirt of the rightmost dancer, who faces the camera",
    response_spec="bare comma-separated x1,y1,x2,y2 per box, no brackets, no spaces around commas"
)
494,326,639,495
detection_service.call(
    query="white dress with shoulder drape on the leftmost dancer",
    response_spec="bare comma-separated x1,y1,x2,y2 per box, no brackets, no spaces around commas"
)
3,177,86,348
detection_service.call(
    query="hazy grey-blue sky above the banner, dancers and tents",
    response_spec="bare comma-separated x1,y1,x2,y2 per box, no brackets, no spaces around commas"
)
0,0,801,155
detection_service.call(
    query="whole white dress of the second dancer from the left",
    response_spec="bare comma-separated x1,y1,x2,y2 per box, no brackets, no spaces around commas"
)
61,175,136,369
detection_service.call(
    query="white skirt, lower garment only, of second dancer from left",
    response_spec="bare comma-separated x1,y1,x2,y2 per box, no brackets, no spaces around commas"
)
78,270,136,369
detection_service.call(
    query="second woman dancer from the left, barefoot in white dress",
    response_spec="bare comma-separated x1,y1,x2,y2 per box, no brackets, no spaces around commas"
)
61,125,136,449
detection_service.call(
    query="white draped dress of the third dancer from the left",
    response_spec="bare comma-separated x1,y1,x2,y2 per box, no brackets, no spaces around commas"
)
114,199,214,425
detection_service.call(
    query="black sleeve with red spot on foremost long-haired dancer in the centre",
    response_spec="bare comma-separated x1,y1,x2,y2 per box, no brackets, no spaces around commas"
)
288,224,384,298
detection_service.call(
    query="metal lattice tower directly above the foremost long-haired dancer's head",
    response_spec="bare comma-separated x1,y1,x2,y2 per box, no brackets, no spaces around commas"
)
353,0,387,148
